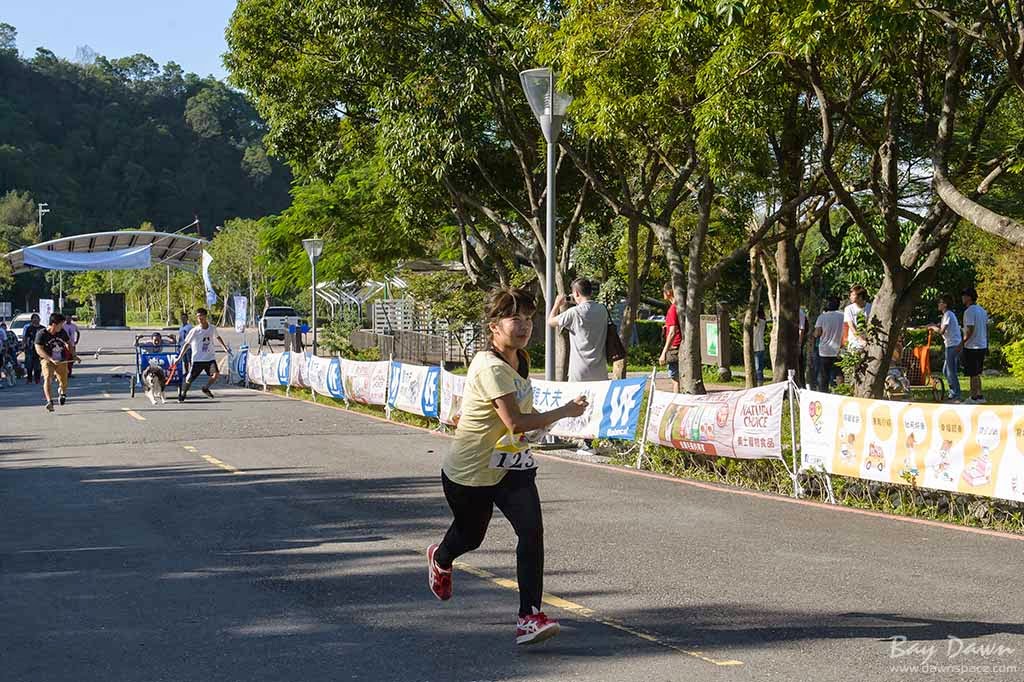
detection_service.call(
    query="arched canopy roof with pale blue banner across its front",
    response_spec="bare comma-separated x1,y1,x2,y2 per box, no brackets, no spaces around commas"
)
2,229,207,274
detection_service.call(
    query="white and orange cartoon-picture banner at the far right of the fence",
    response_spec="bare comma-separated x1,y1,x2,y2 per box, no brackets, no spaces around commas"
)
800,391,1024,502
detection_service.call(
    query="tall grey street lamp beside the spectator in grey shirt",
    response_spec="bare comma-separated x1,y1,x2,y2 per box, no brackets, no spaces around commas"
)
519,69,572,381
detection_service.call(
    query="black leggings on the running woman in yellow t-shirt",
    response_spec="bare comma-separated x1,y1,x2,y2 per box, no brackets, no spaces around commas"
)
434,470,544,615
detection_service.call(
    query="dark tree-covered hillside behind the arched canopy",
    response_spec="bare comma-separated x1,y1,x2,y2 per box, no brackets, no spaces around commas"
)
0,25,291,246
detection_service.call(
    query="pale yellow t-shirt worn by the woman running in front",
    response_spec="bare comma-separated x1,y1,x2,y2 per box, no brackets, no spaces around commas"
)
442,350,534,487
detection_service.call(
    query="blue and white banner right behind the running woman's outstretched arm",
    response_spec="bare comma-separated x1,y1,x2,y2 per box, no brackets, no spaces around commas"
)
531,377,647,440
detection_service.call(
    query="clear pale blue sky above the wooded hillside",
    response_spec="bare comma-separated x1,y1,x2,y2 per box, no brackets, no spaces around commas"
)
0,0,236,78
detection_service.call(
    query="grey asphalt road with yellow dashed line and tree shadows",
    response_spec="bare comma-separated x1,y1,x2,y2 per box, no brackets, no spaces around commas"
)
0,331,1024,682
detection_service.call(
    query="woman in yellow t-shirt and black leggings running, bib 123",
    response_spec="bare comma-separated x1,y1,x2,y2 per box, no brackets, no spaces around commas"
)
427,289,587,644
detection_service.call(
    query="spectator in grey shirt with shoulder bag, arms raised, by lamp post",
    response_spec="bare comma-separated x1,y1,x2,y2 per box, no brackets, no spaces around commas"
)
548,278,608,381
